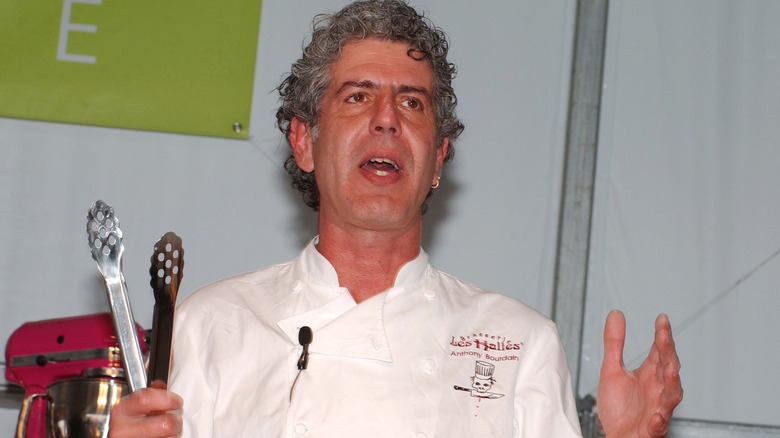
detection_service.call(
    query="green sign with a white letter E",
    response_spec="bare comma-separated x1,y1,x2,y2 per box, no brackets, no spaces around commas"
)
0,0,261,138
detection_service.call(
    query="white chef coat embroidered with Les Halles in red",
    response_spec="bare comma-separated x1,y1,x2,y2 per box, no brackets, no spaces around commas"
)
171,239,580,438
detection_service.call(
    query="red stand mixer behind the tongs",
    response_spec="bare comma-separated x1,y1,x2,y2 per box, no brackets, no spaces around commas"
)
5,313,147,438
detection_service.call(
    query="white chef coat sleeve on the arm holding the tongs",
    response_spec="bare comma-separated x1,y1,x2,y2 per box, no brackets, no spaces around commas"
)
169,306,214,438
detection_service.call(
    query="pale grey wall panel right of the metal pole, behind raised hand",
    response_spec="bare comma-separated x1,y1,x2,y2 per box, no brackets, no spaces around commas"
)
579,0,780,428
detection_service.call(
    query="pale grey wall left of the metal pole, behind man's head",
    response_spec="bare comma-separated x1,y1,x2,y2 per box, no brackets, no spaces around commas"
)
0,0,574,435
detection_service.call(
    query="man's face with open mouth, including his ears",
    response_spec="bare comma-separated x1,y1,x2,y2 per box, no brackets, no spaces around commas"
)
291,39,448,234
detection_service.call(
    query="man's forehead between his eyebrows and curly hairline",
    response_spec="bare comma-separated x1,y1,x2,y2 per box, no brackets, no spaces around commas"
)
330,38,433,90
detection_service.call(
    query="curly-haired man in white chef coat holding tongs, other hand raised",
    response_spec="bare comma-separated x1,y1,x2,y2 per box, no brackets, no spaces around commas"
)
111,0,682,438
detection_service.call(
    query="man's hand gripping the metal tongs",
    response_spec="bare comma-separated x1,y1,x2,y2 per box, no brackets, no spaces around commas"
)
108,381,183,438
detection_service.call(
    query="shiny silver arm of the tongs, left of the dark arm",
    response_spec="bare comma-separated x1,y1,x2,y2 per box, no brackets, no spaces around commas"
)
87,200,146,392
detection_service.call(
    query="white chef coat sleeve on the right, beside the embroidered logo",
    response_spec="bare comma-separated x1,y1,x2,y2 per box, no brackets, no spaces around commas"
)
514,320,582,438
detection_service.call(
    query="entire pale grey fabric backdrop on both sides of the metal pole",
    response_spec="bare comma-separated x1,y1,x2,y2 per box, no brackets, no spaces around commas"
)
0,0,780,435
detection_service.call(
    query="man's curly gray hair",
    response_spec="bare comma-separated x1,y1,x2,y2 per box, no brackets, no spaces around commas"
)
276,0,463,212
